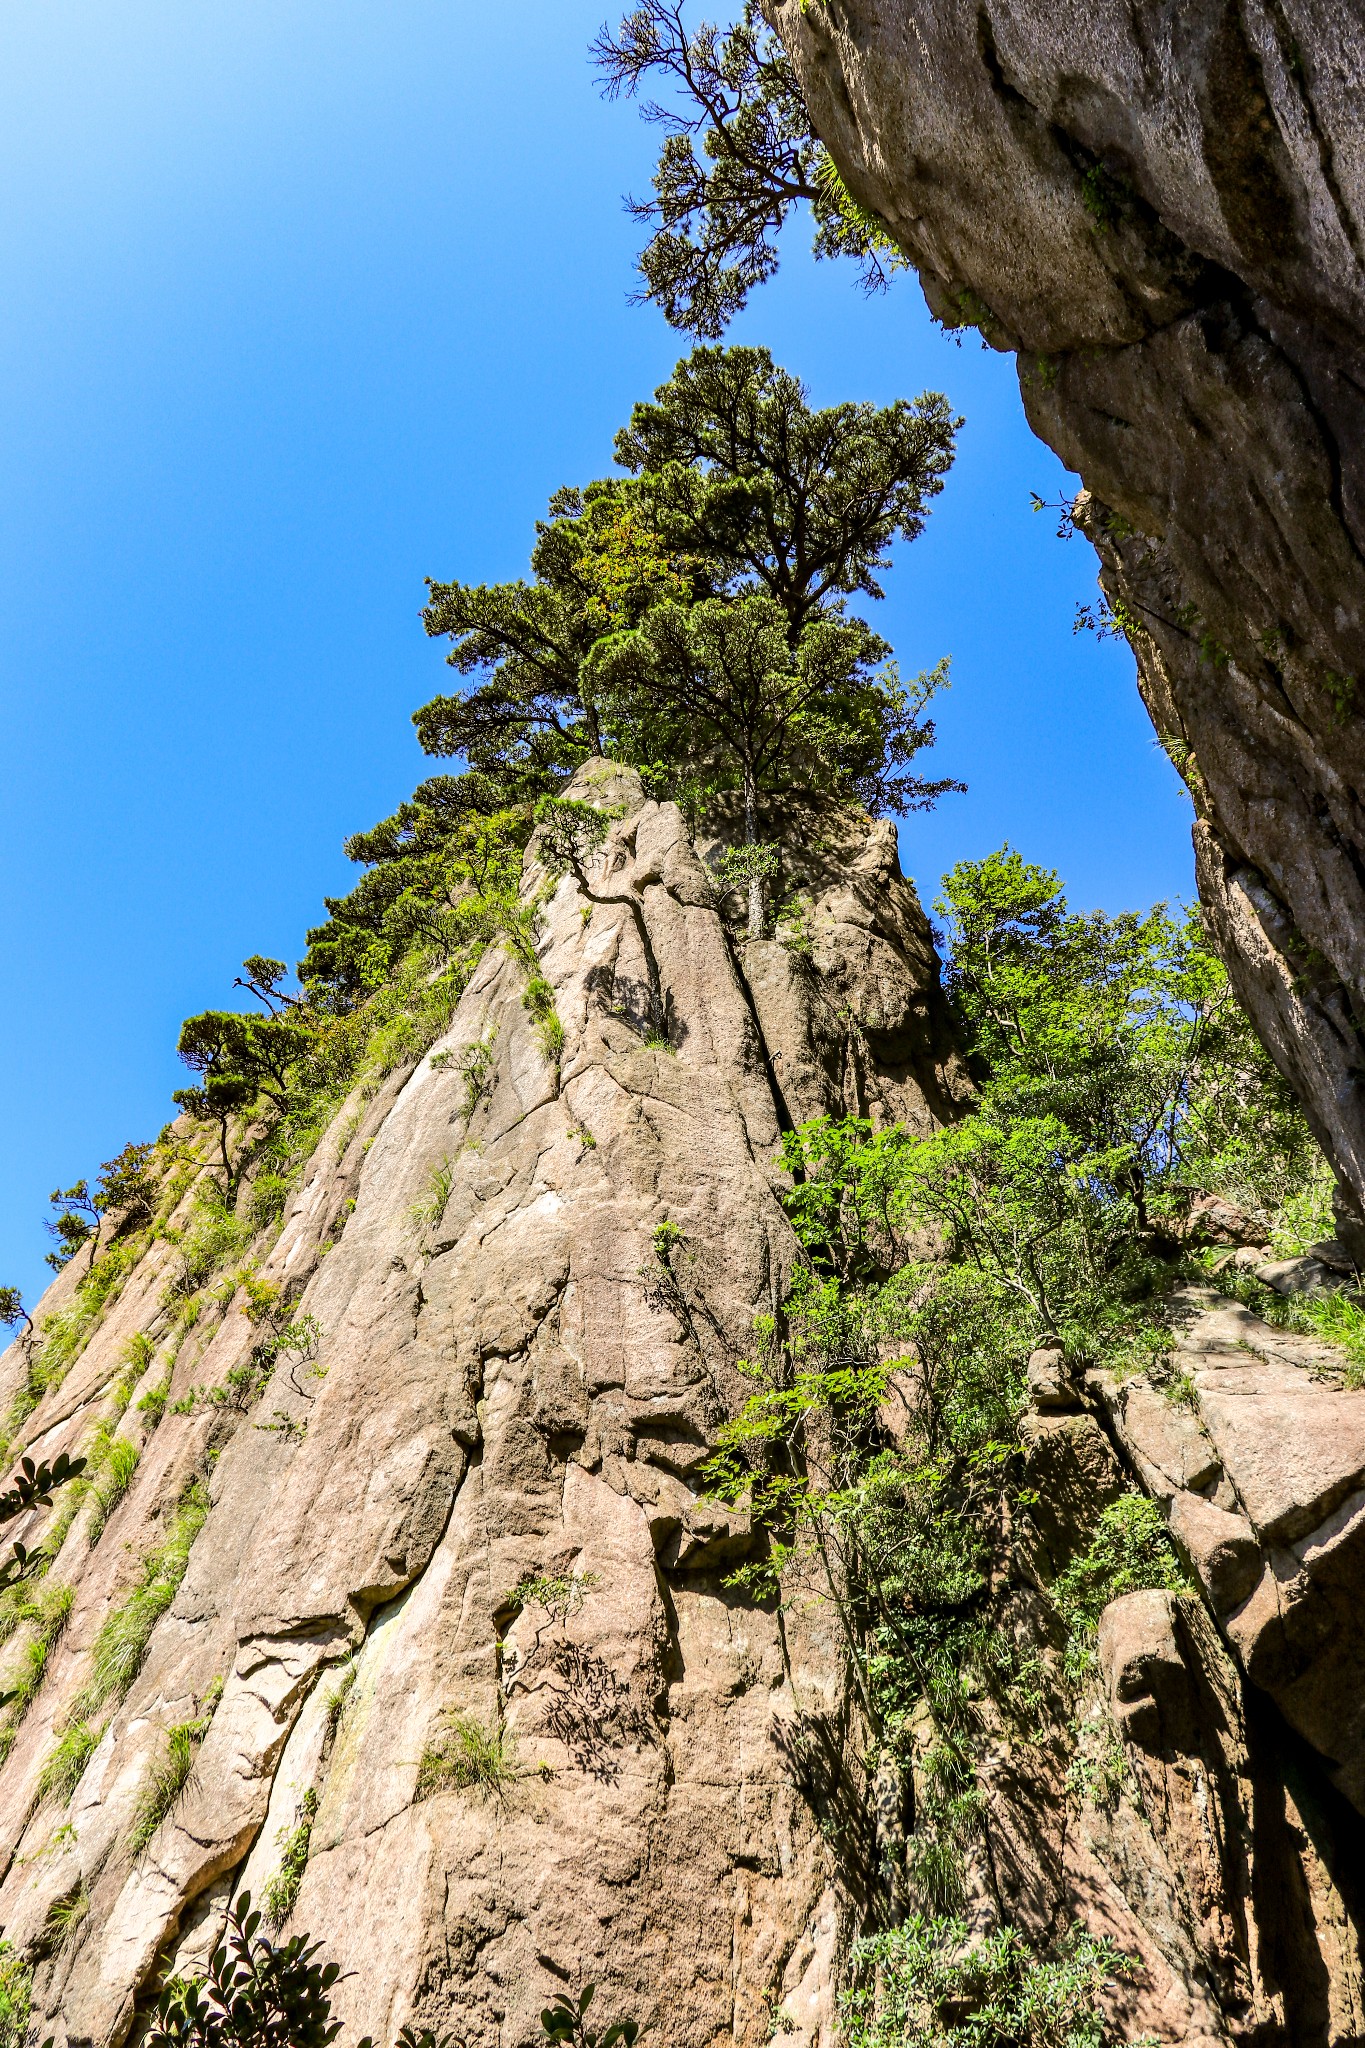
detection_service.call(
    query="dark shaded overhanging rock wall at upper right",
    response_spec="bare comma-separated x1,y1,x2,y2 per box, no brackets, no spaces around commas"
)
767,0,1365,1251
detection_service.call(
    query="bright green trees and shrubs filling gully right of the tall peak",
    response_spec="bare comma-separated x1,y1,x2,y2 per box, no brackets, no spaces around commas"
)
703,848,1326,1970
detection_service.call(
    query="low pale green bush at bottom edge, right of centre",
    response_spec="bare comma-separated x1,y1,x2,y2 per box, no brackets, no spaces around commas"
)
841,1915,1138,2048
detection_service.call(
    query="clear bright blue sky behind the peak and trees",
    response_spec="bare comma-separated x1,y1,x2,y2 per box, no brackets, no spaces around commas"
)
0,0,1191,1294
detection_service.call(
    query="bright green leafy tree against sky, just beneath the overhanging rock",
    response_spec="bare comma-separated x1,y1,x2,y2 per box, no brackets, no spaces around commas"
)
935,846,1316,1237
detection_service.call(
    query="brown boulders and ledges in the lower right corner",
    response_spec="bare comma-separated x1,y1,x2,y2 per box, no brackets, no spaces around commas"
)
1019,1288,1365,2044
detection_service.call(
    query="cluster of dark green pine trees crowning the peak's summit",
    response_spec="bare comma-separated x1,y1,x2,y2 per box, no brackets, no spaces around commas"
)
415,348,960,897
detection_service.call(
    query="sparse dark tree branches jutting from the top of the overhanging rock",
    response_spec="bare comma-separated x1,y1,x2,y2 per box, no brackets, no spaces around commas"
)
593,0,905,338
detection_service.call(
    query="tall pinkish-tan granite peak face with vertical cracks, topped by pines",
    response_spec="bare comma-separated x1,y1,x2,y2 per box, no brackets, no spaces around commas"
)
0,764,964,2048
